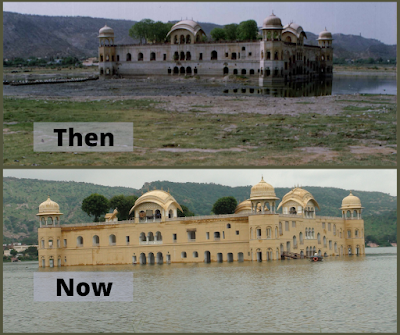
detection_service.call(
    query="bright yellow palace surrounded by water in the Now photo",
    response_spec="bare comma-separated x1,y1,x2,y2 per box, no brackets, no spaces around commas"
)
37,179,365,267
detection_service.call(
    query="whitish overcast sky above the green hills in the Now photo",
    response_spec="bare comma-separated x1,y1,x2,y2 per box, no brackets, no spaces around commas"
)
3,169,397,196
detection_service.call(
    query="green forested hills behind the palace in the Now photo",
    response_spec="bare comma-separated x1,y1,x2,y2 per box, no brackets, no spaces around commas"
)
3,176,397,244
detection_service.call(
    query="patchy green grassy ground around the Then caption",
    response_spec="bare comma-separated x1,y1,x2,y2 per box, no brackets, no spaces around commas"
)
3,95,397,166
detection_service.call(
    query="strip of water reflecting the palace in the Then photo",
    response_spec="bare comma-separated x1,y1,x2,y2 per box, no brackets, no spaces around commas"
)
223,75,397,98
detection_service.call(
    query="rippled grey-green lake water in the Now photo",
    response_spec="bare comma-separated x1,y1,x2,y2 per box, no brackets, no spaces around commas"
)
3,248,397,333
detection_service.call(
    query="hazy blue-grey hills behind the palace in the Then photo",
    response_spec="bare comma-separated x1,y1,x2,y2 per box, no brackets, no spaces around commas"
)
3,12,396,59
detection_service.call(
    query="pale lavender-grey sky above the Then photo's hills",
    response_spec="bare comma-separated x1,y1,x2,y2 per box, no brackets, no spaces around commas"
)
3,2,397,44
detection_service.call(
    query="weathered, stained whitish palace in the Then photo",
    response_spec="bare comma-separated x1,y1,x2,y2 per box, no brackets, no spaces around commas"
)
98,14,333,83
